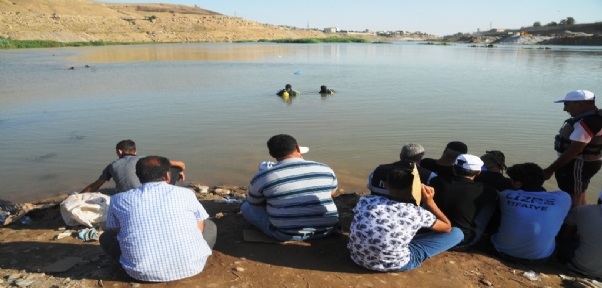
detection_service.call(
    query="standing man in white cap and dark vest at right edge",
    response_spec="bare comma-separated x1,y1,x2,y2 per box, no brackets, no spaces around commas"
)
544,90,602,206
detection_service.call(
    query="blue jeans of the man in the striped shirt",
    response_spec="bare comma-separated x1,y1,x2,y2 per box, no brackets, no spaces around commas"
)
240,202,338,241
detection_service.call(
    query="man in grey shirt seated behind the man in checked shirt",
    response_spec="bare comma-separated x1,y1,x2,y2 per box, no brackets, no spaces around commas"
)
81,140,186,194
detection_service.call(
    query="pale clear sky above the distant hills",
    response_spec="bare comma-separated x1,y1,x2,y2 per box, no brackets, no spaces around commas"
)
102,0,602,36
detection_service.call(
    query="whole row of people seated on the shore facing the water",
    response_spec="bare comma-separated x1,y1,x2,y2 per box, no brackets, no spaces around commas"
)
84,134,602,282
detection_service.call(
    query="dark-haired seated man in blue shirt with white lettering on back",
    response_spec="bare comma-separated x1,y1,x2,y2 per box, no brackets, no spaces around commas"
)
491,163,571,261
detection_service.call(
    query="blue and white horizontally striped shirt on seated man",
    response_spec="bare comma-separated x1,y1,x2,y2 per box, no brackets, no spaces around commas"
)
247,158,339,234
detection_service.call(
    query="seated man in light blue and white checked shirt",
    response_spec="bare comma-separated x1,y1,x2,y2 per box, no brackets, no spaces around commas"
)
100,156,217,282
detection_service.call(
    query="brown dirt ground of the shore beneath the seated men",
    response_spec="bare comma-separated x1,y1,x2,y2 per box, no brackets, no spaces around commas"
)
0,187,595,288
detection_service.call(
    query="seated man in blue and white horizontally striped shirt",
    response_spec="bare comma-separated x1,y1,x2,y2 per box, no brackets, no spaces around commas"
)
241,134,338,241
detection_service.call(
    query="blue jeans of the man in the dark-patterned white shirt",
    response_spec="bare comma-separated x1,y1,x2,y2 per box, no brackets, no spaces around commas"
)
398,227,464,272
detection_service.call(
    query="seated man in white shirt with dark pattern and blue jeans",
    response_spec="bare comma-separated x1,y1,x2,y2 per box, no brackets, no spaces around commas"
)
347,168,464,272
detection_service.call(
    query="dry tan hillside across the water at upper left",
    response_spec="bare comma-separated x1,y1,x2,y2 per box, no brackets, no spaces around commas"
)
0,0,326,42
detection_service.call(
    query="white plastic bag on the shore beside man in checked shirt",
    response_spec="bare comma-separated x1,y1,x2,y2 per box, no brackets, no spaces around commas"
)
61,192,111,227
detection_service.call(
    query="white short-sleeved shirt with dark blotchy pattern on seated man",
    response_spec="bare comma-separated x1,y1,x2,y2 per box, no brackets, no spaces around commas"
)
347,195,437,271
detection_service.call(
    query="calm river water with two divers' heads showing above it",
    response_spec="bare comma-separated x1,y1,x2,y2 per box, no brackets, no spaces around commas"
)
0,42,602,202
